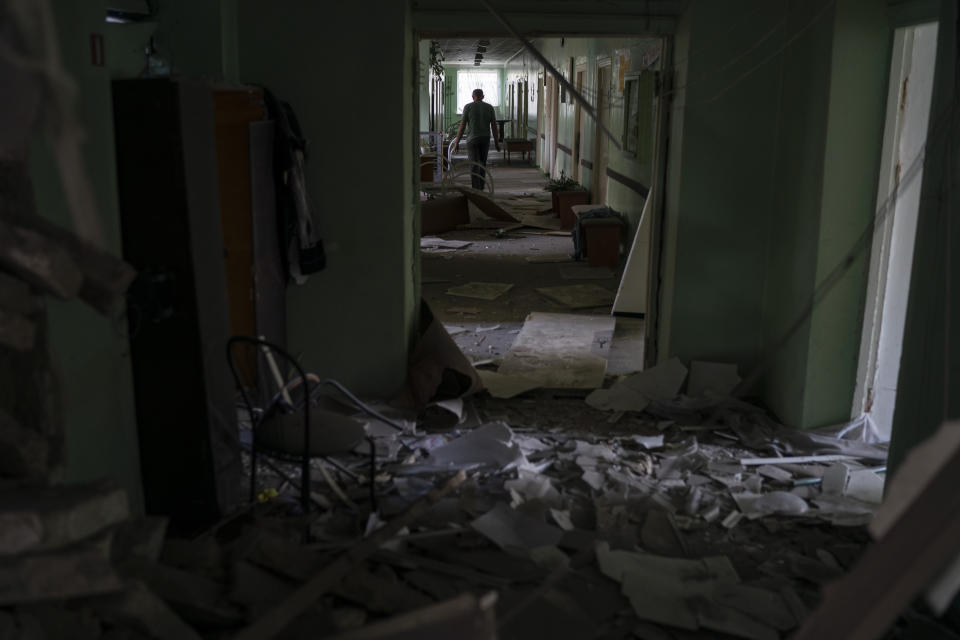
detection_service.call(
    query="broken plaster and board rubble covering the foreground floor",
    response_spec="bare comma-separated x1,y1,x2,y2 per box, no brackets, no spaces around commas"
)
0,350,916,639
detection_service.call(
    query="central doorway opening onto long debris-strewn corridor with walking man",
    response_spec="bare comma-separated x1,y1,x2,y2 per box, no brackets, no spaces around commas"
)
418,36,664,388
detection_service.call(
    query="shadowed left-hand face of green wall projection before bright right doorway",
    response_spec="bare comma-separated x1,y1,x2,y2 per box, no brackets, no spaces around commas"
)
747,3,840,425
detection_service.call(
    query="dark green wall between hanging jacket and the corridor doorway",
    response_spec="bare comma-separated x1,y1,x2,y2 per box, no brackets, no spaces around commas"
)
238,0,417,394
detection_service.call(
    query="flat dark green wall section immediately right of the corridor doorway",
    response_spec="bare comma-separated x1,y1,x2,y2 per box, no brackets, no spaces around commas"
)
658,0,783,376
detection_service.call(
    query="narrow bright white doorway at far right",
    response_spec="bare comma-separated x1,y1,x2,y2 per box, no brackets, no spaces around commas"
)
852,23,937,440
